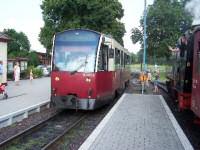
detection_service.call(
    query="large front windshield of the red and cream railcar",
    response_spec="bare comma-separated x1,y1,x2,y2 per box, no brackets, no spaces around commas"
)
53,30,100,72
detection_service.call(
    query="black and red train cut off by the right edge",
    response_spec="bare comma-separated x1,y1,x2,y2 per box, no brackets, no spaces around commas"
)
167,26,200,118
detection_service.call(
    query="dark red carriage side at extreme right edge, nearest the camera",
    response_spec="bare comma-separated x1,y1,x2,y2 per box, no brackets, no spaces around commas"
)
192,30,200,117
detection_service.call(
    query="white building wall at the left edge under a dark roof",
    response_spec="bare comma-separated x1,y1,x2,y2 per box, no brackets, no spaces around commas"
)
0,42,7,83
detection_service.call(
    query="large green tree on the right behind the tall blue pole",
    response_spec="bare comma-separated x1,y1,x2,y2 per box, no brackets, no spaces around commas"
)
131,0,192,57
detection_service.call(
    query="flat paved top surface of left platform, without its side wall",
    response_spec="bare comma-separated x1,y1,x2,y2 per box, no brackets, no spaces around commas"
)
0,77,50,117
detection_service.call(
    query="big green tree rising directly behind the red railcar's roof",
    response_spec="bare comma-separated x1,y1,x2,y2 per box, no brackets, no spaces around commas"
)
39,0,125,52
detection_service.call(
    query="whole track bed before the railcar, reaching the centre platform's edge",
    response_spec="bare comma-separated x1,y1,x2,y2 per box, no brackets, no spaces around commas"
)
0,97,119,150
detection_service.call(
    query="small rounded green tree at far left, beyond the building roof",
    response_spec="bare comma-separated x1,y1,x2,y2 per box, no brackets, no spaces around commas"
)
3,29,31,56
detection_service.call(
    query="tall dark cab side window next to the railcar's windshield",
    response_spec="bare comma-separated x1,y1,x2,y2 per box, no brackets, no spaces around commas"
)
98,44,108,71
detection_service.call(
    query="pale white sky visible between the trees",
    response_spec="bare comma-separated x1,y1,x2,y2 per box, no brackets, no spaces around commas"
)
0,0,153,53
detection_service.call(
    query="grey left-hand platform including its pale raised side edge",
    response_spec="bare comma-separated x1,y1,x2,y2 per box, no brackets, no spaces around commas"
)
0,77,50,128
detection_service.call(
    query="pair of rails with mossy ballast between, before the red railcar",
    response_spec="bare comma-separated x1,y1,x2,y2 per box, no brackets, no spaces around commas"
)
0,112,87,150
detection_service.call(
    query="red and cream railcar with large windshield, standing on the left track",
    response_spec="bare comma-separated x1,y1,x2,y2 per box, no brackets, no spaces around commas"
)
51,29,130,110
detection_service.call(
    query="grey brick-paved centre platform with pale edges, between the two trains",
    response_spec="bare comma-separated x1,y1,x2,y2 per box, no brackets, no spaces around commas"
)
79,94,193,150
